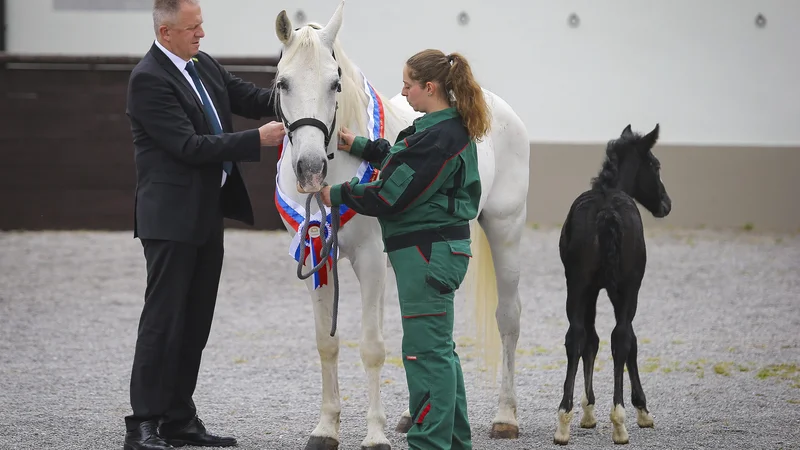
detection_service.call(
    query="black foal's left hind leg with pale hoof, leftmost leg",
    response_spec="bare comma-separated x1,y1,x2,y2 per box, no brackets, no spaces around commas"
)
553,280,597,445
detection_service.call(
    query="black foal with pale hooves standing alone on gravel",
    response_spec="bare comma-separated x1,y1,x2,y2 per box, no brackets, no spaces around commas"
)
554,125,672,444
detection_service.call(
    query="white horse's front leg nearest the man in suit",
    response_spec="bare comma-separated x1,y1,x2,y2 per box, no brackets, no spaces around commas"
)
305,280,342,450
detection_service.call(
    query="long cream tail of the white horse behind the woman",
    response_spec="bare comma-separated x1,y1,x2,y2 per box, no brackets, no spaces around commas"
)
465,220,502,382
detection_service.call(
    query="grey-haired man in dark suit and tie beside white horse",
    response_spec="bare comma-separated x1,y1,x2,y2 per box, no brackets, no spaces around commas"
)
125,0,284,450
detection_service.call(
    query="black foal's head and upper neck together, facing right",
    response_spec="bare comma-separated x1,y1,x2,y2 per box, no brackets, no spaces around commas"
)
592,124,672,217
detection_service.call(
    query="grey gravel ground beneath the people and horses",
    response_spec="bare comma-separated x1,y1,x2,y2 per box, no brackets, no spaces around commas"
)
0,229,800,449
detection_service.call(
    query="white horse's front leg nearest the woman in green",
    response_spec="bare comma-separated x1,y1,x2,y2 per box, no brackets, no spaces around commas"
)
351,240,391,450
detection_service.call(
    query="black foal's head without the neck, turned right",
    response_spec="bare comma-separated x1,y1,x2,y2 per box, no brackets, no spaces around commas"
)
618,124,672,217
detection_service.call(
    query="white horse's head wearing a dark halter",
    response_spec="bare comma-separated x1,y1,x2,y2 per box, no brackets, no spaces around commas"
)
275,1,344,192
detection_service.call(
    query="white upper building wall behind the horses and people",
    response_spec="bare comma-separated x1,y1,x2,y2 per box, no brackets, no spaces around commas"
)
6,0,800,146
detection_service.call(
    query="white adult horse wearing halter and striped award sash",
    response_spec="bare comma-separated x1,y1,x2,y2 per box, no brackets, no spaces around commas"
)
275,1,530,449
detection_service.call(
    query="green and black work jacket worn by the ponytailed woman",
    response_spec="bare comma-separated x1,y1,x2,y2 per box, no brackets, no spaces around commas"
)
331,107,481,239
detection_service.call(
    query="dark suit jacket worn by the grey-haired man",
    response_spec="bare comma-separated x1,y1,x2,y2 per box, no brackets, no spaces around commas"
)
126,43,276,244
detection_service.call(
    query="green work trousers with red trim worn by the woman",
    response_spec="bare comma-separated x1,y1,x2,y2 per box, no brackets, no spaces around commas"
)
389,240,472,450
